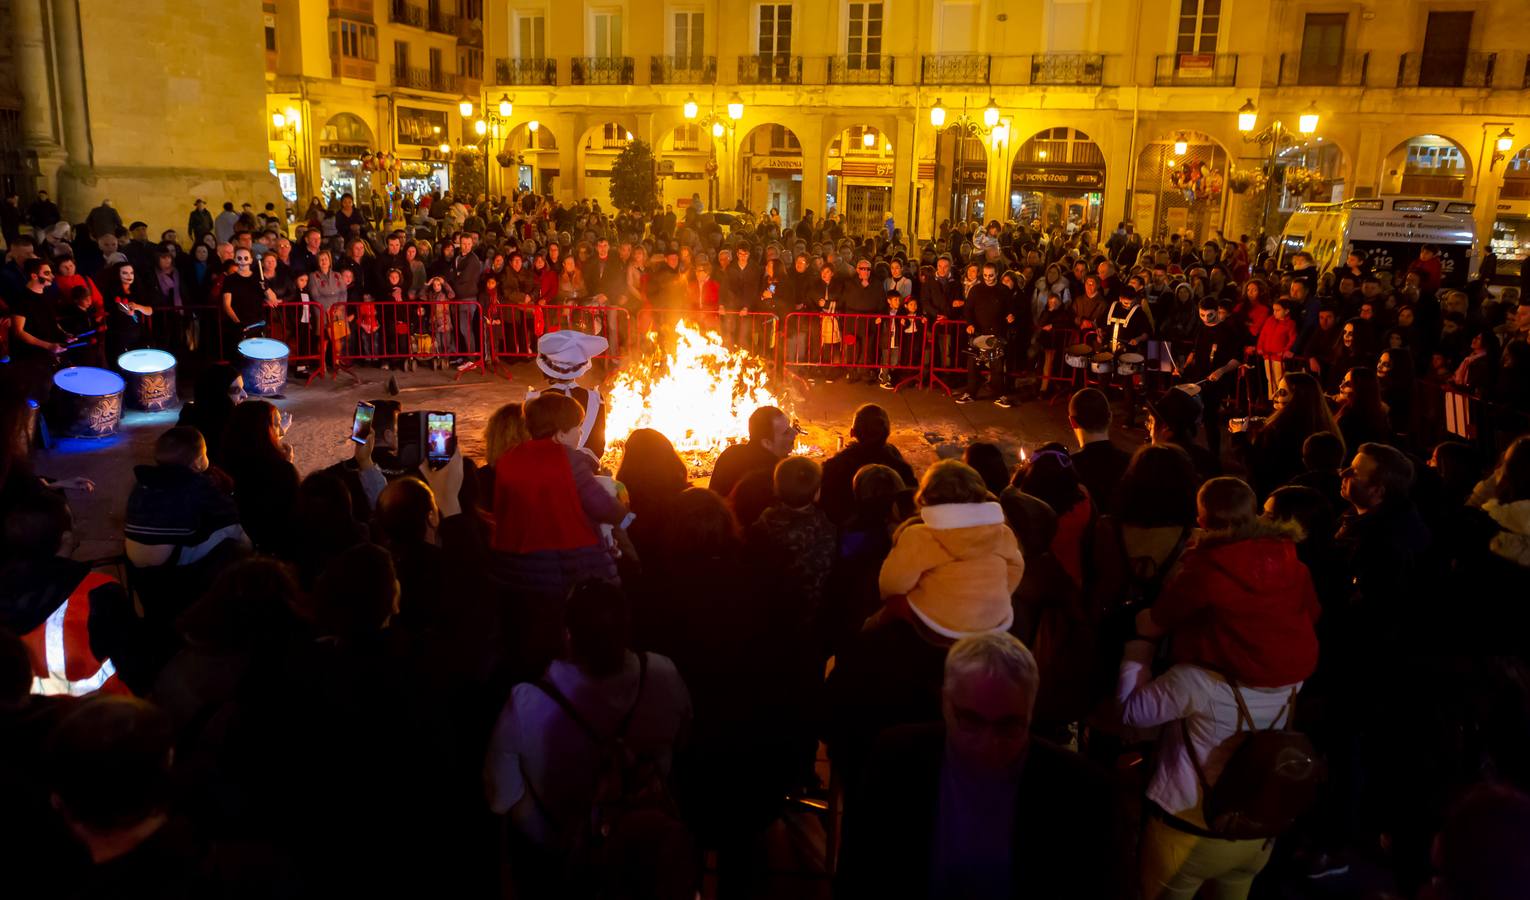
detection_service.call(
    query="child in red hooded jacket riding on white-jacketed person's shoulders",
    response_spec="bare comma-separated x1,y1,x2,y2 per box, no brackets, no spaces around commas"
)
1137,478,1319,687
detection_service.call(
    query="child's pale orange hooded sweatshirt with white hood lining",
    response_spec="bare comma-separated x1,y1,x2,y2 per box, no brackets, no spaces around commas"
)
878,502,1025,638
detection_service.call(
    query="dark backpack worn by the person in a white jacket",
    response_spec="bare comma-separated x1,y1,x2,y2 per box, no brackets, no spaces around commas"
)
1180,680,1325,840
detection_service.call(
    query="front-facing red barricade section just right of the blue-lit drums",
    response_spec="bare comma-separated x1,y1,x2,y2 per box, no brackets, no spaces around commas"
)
327,300,487,380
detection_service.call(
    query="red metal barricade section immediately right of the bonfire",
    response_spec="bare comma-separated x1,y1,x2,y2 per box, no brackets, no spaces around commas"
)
780,312,929,390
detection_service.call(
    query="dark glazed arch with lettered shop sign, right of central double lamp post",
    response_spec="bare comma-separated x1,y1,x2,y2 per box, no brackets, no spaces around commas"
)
1010,127,1105,236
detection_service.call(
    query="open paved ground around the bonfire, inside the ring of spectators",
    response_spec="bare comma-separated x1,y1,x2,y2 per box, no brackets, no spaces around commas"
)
38,358,1113,559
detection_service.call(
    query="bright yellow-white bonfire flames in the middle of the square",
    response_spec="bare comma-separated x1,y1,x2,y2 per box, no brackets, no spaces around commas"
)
606,318,785,476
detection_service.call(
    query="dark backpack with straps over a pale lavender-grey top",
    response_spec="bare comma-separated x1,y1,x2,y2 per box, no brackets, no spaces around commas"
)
526,654,693,897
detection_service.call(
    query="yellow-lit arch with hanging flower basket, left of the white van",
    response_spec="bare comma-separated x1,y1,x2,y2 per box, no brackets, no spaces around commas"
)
1131,132,1227,243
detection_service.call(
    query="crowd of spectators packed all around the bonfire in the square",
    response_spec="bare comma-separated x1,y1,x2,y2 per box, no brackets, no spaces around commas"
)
0,185,1530,900
